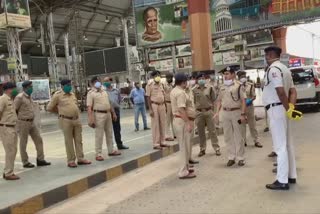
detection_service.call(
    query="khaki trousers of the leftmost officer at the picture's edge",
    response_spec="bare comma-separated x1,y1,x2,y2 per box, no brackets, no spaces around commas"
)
0,126,18,176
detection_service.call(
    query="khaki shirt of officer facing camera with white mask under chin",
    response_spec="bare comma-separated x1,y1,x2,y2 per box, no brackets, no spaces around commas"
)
218,81,247,108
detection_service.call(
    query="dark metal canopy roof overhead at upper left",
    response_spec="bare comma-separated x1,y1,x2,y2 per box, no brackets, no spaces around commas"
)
0,0,135,56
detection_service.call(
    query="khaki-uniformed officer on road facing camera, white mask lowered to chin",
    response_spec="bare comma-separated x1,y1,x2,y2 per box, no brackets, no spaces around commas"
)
215,67,246,167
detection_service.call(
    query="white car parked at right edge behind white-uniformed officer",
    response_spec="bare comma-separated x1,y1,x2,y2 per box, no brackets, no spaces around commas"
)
290,66,320,110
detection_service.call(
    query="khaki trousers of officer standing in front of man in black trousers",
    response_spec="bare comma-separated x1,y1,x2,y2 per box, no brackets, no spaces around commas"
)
94,112,113,156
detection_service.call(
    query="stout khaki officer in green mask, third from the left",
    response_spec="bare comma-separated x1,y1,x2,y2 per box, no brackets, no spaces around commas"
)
47,79,91,168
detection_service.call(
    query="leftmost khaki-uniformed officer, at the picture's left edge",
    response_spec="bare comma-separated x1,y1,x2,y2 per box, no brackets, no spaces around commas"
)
0,82,20,180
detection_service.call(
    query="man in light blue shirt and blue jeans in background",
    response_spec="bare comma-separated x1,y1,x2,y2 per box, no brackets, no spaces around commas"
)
130,82,149,132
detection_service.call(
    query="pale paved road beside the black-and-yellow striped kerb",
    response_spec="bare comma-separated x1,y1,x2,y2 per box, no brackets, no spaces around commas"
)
43,108,320,214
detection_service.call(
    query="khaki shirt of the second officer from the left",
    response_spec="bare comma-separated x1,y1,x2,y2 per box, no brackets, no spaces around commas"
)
14,92,35,120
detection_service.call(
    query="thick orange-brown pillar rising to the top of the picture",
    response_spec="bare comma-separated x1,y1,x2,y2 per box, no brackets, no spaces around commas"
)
188,0,213,71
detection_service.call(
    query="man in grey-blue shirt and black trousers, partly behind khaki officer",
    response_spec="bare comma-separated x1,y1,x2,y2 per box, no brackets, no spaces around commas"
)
103,77,129,150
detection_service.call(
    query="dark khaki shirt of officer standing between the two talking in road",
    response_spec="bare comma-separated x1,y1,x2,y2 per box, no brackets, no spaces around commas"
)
193,85,215,110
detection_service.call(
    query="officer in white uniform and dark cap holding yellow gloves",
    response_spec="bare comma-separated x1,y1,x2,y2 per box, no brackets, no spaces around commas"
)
262,47,302,190
